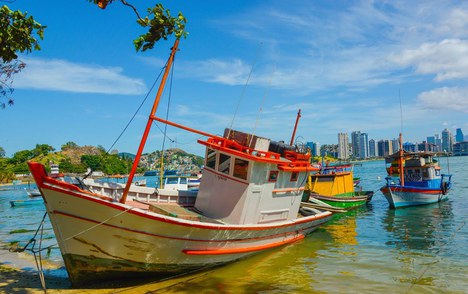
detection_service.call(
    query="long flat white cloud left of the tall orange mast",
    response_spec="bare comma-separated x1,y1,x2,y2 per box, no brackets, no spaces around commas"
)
14,58,147,95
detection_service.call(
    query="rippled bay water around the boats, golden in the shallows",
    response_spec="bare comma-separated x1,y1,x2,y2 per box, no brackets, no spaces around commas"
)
0,157,468,293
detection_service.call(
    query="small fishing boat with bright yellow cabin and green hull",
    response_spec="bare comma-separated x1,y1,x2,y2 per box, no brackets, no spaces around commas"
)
303,164,374,209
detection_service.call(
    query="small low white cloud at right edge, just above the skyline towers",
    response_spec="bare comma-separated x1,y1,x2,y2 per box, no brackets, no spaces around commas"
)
418,87,468,113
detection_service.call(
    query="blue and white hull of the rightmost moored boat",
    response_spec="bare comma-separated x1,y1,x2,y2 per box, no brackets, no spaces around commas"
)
380,185,448,208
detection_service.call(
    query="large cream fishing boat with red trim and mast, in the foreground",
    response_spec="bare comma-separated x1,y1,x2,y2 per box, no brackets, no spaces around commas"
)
28,40,332,287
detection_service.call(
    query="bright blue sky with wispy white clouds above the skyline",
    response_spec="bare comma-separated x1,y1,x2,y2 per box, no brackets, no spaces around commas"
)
0,0,468,157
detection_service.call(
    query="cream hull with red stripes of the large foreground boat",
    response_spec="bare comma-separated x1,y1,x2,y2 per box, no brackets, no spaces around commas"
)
41,179,331,287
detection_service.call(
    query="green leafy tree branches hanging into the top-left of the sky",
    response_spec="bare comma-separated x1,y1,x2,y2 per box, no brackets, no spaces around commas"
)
0,0,187,108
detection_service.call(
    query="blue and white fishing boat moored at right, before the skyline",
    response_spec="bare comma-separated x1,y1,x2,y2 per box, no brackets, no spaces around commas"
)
380,134,452,208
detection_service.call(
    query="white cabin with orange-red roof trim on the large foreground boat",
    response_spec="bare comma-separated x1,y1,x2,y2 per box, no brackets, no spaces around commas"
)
195,129,314,224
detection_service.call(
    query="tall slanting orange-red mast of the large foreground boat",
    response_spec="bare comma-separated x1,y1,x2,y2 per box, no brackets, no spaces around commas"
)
120,39,179,203
